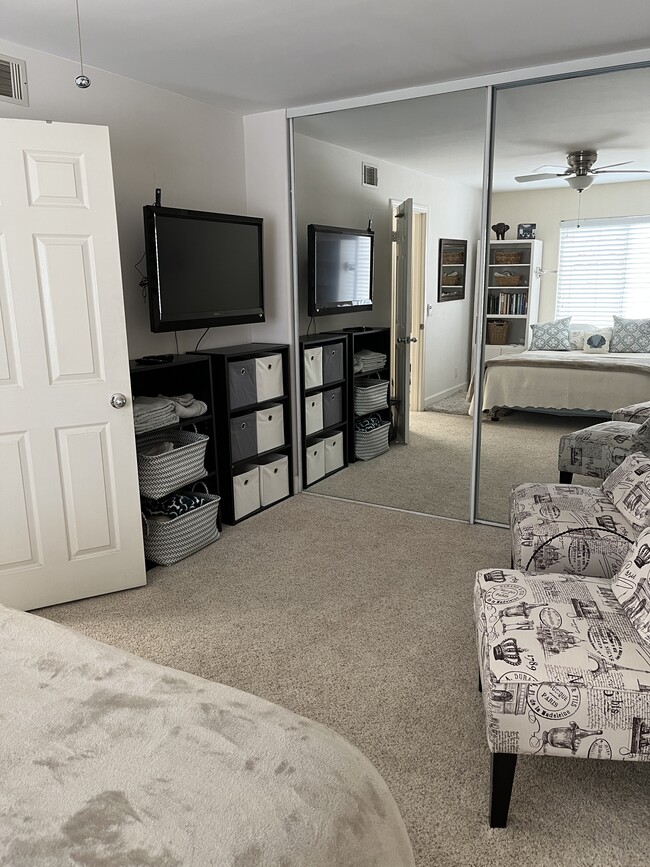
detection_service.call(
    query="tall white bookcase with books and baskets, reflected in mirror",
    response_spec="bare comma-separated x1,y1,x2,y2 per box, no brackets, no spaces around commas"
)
485,241,542,359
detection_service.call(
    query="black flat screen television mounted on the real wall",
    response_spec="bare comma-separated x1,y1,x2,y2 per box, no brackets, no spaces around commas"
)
144,205,264,331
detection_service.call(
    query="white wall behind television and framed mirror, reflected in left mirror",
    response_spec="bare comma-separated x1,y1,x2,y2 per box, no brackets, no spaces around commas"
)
295,134,481,402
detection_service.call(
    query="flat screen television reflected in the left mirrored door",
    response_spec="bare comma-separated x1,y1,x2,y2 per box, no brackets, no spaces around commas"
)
307,224,375,316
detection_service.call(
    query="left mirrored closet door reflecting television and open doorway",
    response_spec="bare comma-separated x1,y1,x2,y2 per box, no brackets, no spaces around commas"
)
293,89,486,520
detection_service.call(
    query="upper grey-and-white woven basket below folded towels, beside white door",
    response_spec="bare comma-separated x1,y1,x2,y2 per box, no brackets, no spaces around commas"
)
136,430,209,500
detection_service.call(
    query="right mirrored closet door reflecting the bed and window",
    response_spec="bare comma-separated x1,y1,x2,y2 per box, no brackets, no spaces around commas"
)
477,67,650,523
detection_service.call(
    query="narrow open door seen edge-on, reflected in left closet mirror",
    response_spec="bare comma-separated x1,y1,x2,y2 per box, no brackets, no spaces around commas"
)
393,199,417,444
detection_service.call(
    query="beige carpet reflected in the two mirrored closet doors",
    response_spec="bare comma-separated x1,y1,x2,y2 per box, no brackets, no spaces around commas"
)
309,412,592,523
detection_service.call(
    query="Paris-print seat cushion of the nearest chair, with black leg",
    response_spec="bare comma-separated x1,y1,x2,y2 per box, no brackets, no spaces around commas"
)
474,570,650,761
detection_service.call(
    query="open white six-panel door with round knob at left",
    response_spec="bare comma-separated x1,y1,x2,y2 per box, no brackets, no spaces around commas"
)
0,119,145,609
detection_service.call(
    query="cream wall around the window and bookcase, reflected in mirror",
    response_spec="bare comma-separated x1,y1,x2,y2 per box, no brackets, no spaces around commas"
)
491,180,650,322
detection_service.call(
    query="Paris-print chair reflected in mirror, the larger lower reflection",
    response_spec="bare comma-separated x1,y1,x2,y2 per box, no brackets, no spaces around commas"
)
557,418,650,484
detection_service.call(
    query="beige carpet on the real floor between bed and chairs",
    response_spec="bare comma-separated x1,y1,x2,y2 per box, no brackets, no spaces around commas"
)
41,495,650,867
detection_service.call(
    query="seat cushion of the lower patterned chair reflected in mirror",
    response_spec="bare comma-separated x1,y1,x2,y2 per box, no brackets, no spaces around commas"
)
557,421,639,479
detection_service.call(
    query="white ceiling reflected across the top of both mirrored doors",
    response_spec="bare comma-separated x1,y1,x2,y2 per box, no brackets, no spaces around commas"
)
295,68,650,191
